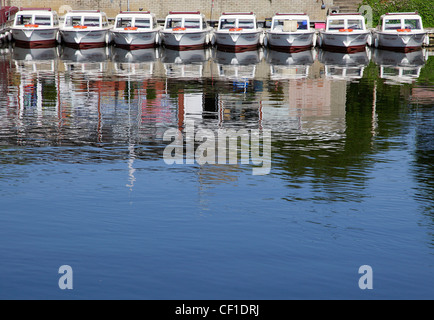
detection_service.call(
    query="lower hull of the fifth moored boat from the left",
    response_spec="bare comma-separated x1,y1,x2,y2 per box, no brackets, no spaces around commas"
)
214,31,262,51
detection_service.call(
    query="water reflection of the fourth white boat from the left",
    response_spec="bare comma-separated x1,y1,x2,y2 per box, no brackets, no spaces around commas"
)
161,48,210,78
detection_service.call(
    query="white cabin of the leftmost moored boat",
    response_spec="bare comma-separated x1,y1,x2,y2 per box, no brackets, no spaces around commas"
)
14,8,59,28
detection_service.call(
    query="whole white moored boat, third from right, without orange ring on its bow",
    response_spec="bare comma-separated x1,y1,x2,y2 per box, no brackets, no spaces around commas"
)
264,13,316,51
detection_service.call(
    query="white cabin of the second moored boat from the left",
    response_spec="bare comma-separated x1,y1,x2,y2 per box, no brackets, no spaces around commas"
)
64,10,109,28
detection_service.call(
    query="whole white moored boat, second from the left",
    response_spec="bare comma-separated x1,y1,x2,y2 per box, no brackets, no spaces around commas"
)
60,10,111,48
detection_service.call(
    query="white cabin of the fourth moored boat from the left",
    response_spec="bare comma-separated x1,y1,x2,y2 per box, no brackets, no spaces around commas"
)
164,11,208,31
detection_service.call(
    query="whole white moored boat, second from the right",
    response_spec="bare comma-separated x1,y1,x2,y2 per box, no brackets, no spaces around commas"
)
317,13,370,52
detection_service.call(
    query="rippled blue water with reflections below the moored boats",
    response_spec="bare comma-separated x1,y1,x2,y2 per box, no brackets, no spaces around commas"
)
0,47,434,299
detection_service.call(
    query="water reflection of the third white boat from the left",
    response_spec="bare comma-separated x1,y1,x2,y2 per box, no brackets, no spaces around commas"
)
112,47,158,77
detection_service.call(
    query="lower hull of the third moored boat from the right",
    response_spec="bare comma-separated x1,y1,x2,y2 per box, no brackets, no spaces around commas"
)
267,32,315,51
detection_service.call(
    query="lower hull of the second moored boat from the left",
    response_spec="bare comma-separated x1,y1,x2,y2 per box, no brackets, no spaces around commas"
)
60,29,109,48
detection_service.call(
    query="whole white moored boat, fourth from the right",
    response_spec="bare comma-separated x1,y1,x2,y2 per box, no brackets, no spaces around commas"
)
213,12,265,51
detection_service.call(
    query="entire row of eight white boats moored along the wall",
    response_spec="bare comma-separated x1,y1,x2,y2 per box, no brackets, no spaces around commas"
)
5,8,428,52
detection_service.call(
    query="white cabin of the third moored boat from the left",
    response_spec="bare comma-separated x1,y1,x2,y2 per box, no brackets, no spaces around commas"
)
115,11,158,30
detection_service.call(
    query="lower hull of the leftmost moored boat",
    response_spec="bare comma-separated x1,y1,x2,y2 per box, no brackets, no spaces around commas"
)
11,28,59,48
